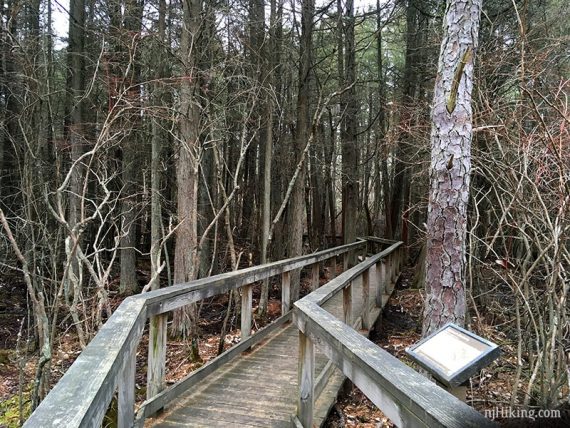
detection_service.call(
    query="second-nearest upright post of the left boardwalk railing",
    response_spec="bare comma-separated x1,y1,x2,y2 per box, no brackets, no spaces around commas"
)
146,314,168,399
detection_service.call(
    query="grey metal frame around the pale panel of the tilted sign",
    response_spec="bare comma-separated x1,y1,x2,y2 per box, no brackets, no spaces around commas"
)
406,323,501,387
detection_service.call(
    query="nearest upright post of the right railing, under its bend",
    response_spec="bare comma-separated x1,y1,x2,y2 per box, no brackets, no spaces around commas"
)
297,332,315,428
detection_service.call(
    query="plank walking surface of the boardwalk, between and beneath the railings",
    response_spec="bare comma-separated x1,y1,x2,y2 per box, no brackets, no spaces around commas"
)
145,270,393,427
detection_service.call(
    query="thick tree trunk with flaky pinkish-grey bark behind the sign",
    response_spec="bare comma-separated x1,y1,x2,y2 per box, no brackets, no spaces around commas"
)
423,0,481,335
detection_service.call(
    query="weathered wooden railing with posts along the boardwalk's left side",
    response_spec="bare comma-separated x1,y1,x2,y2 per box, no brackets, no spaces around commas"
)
24,240,367,428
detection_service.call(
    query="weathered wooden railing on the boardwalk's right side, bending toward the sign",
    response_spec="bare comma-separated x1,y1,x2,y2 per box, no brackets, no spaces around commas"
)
293,242,495,428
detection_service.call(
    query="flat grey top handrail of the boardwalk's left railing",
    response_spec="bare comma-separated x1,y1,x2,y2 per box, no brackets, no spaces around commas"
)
24,241,366,428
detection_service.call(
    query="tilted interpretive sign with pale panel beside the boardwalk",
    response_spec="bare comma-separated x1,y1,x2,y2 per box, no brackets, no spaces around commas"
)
406,323,501,387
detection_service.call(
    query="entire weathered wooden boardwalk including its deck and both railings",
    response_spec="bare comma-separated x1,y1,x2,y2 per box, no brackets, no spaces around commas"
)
24,241,496,428
